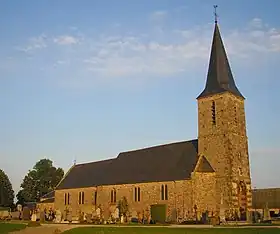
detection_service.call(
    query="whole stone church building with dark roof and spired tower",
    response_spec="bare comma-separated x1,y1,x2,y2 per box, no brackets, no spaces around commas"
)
54,22,252,220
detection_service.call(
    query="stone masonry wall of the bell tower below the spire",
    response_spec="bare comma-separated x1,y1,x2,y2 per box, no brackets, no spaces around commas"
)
198,92,251,217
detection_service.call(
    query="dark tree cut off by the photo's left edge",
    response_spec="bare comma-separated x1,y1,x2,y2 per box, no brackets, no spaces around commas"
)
0,169,15,207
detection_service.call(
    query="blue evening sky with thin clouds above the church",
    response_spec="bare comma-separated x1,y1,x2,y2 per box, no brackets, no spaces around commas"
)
0,0,280,196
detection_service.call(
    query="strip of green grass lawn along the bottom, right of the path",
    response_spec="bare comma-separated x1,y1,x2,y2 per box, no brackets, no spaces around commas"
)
64,227,280,234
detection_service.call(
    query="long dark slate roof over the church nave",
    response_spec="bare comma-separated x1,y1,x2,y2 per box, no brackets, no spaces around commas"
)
56,139,198,190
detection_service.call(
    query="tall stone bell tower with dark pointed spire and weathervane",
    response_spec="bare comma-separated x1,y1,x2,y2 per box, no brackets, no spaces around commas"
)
197,14,252,219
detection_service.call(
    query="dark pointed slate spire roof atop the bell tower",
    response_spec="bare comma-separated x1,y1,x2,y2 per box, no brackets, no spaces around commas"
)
197,23,244,99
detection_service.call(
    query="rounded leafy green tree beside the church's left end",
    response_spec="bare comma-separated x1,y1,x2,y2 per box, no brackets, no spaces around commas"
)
17,159,64,204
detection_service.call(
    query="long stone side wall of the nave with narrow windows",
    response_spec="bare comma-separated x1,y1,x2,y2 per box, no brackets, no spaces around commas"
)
55,180,193,219
